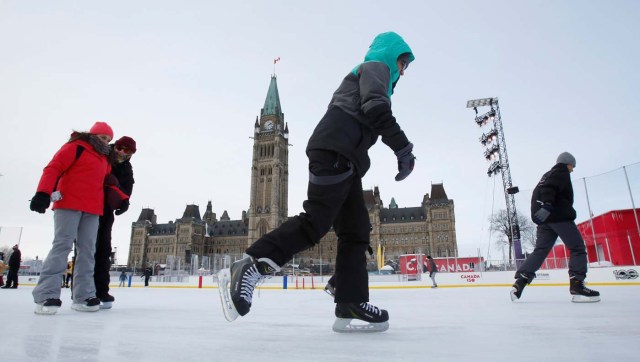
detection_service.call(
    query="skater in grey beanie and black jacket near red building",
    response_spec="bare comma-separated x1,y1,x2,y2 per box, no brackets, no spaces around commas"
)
511,152,600,302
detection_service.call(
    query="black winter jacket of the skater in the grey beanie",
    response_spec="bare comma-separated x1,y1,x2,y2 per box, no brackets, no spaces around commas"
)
531,163,576,223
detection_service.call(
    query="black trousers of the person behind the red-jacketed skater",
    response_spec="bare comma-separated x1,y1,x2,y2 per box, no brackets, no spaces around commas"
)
93,209,114,298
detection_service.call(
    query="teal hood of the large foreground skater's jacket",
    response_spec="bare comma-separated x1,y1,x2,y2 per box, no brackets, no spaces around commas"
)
352,31,415,96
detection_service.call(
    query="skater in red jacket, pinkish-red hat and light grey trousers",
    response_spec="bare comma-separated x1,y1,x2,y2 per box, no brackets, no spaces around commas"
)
30,122,113,314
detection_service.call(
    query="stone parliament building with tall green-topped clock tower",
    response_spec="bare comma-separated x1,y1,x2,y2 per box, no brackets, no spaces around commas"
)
127,76,458,272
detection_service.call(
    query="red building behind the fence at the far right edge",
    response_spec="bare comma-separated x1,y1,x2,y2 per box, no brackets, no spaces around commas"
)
547,209,640,265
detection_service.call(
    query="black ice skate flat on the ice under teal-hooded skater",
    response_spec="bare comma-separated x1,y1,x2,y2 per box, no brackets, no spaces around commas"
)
333,303,389,333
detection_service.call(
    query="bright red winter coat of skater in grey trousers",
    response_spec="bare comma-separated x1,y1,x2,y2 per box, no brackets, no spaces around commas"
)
38,140,111,216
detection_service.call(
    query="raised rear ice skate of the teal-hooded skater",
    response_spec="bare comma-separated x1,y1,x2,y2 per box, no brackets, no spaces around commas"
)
218,255,280,322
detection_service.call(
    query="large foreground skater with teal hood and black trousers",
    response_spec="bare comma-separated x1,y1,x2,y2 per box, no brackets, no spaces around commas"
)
221,32,415,332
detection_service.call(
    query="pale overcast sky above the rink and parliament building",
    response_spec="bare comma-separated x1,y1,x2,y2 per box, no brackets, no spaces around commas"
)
0,0,640,263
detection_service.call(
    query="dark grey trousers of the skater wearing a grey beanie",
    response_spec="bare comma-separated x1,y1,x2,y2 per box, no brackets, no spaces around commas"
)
516,221,587,281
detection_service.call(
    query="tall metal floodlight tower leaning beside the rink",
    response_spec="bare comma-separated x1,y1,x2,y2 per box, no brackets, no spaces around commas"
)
467,97,524,261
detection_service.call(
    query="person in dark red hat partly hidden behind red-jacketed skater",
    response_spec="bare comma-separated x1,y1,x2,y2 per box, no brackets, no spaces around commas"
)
93,136,137,309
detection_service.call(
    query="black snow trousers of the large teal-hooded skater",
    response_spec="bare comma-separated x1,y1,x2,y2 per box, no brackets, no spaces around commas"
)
246,150,371,303
